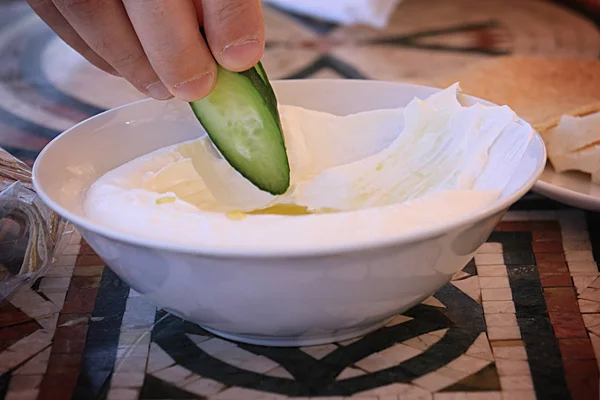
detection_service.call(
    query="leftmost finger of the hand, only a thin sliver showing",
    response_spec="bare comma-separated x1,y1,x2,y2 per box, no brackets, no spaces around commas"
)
27,0,119,76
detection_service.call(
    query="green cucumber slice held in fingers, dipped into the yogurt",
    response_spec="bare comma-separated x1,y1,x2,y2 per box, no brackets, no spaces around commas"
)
190,66,290,195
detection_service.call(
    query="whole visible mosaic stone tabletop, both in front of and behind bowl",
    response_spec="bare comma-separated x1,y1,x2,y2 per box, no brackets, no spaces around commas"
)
0,0,600,400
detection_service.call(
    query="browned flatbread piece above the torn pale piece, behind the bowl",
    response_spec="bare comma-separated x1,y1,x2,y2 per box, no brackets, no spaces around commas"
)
433,56,600,133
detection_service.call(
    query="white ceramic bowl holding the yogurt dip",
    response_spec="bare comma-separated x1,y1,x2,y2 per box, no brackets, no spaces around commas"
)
33,80,546,346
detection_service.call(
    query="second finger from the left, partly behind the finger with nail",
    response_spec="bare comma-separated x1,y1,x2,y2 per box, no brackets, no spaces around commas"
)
53,0,171,100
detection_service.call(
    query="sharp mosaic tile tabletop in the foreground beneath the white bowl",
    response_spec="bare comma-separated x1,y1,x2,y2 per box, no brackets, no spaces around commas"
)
0,208,600,400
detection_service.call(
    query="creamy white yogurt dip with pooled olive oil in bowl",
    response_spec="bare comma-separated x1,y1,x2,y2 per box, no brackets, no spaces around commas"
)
83,85,533,249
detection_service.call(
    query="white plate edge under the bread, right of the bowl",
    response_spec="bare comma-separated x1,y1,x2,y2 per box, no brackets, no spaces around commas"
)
533,163,600,211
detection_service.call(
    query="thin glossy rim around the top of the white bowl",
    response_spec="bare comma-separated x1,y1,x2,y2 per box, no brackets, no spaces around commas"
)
32,79,547,259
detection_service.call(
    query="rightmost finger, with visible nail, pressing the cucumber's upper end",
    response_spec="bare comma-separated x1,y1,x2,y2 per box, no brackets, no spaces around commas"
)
202,0,265,71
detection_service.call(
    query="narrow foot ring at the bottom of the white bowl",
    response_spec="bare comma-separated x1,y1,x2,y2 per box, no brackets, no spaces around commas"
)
202,318,392,347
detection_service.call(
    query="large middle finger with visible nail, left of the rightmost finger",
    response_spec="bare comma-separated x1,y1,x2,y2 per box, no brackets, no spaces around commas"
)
124,0,217,101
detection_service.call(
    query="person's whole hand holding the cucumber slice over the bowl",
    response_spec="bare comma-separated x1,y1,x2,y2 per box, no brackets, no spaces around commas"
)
27,0,265,101
